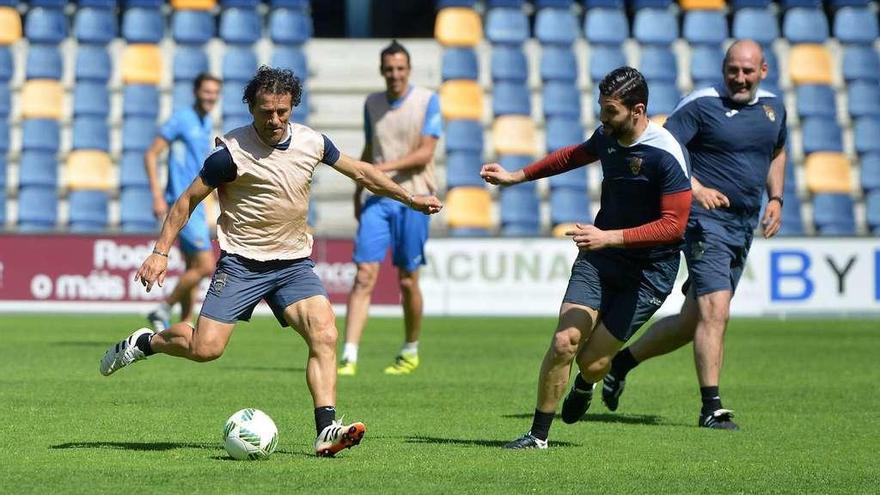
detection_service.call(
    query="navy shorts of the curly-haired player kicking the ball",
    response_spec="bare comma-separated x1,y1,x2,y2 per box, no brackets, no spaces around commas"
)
201,252,327,327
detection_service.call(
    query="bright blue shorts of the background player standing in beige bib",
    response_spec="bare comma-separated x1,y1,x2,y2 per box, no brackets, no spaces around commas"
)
353,196,431,272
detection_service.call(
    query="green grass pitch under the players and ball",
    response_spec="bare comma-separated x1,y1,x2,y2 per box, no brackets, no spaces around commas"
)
0,315,880,494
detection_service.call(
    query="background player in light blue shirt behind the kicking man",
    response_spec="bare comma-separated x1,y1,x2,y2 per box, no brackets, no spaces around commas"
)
144,74,221,331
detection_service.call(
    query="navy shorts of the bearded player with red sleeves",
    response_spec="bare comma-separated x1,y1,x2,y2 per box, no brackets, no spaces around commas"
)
562,251,679,342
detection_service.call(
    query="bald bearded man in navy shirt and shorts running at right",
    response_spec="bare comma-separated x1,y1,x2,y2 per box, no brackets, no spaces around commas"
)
602,40,787,430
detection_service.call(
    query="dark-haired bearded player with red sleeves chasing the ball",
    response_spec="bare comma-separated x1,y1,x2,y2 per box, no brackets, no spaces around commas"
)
481,67,691,449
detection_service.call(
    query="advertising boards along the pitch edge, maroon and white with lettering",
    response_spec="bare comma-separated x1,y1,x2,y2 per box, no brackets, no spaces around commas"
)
0,235,880,316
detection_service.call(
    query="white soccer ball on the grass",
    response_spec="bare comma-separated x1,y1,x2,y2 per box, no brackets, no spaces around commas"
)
223,407,278,460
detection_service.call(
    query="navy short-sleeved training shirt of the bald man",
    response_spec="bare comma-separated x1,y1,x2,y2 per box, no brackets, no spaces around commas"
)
665,85,788,217
